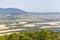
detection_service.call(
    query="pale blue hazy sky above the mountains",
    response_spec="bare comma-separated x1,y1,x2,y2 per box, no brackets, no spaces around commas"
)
0,0,60,12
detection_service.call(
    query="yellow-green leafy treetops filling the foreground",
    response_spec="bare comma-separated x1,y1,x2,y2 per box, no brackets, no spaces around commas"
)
0,30,60,40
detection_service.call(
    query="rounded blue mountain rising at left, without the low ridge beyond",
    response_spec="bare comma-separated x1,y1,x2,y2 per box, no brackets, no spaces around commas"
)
0,8,27,15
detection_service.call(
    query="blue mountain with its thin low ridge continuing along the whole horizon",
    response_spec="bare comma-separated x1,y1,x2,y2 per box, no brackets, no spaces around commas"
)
0,8,60,14
